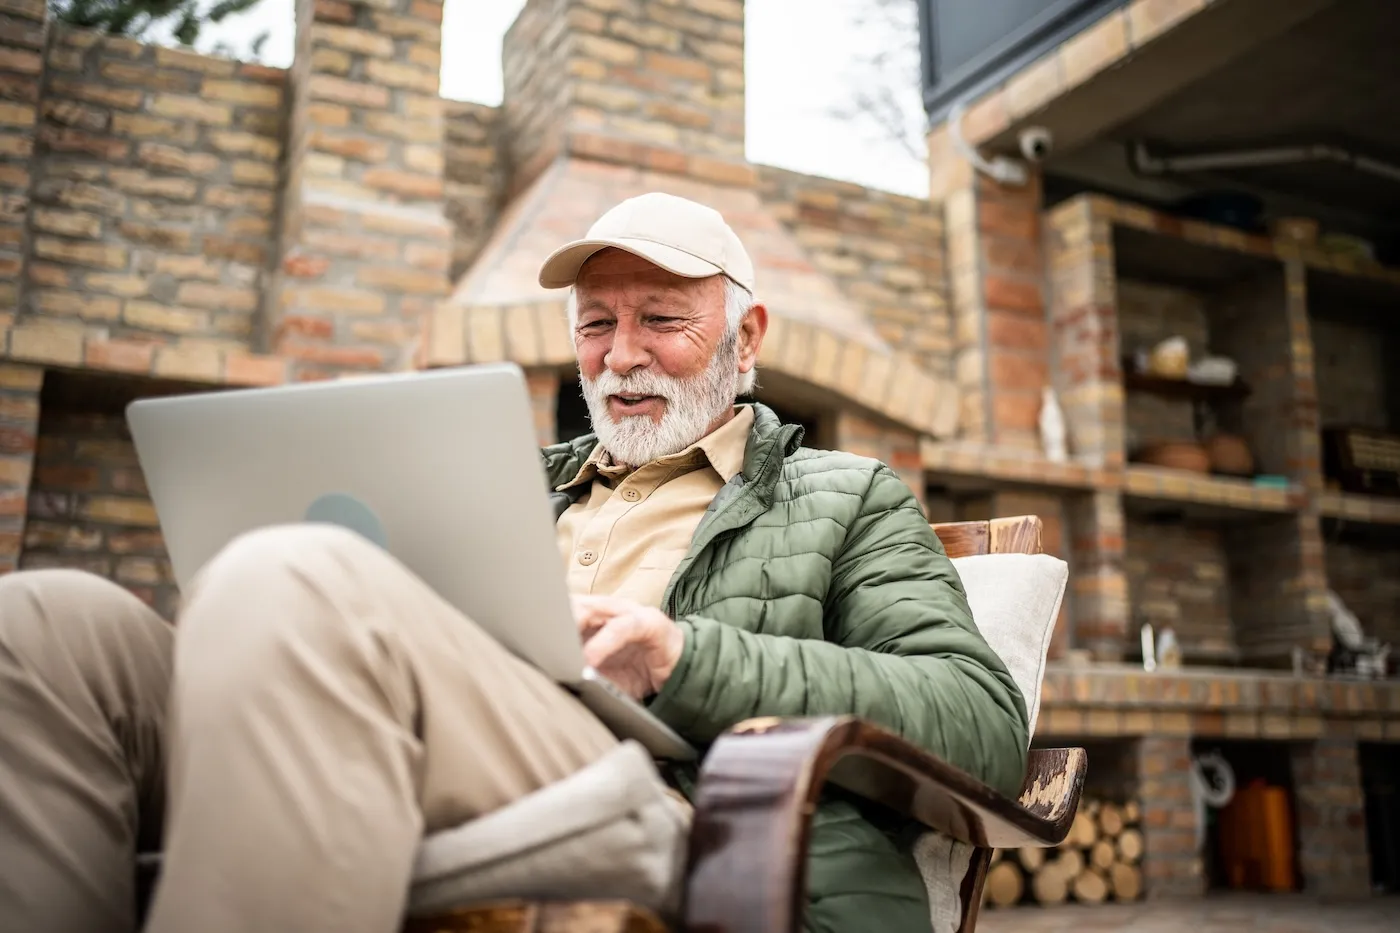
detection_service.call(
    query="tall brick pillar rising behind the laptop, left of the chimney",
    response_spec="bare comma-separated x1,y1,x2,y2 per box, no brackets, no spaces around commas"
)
263,0,451,378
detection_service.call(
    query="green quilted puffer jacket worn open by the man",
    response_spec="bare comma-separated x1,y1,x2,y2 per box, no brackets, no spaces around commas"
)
543,405,1028,933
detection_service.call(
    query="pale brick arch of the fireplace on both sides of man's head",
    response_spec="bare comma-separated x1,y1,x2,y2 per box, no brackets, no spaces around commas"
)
420,301,958,438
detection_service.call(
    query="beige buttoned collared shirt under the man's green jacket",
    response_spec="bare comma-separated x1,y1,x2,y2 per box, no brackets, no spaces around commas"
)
556,406,753,607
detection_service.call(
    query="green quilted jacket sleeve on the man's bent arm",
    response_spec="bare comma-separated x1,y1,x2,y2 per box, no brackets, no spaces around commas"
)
651,467,1029,796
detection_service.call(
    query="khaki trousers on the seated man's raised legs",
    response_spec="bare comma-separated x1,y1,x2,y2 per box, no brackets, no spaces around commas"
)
0,525,617,933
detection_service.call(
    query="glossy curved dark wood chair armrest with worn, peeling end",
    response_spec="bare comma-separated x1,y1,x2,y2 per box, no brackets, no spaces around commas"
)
685,717,1088,933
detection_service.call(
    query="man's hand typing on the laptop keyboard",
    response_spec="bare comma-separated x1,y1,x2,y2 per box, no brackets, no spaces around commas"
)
574,595,686,700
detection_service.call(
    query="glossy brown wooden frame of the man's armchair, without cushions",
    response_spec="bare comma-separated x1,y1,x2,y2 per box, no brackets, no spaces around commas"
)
403,517,1086,933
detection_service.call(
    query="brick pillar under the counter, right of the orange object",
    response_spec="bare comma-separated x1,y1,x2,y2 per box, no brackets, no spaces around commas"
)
1291,738,1371,898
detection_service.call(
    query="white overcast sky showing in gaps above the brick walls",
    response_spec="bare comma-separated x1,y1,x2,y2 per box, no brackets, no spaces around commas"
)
183,0,928,196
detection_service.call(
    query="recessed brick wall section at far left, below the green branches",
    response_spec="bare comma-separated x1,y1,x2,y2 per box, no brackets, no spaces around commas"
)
28,24,286,356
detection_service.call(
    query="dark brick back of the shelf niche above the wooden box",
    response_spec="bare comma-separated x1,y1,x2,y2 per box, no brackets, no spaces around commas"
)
1310,318,1396,430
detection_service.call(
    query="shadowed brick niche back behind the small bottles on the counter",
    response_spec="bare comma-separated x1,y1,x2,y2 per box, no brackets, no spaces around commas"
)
1124,517,1235,663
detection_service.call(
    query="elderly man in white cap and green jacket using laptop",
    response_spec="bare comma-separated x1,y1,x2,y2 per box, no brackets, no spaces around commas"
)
0,195,1028,933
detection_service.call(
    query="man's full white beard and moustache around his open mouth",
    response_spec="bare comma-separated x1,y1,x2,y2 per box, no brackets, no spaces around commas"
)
580,333,739,467
